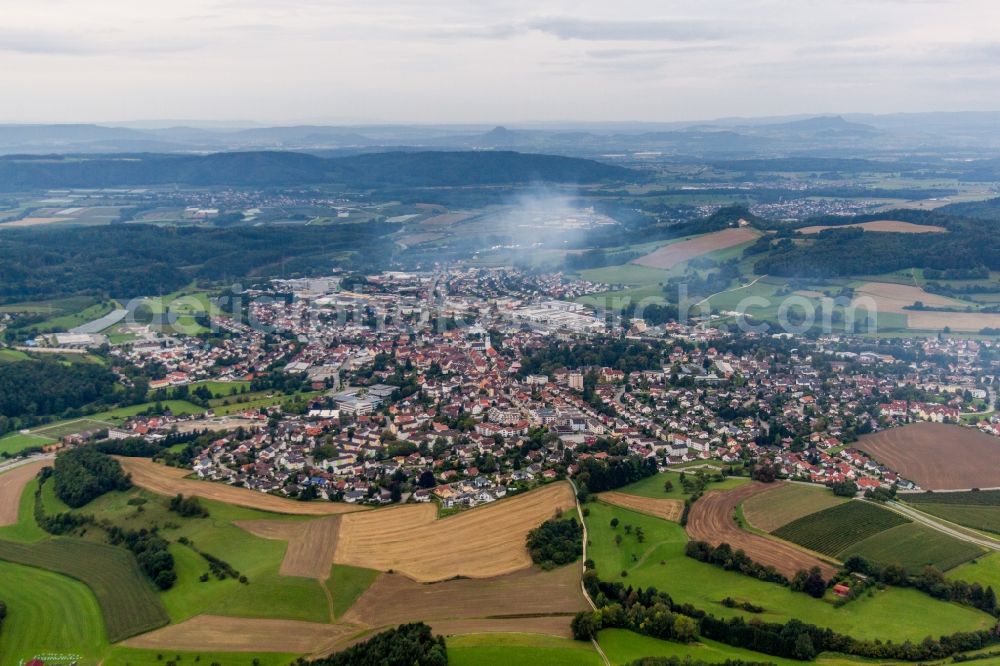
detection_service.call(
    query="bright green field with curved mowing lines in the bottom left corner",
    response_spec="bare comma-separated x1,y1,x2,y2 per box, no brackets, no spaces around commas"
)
0,561,107,665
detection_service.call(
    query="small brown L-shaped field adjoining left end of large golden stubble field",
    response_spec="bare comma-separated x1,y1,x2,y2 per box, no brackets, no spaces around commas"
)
234,516,340,581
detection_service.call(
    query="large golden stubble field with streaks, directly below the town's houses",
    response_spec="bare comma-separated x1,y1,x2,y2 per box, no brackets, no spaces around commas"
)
334,482,575,582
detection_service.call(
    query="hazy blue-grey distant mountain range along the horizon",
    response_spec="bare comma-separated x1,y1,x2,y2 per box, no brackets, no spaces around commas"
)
0,113,1000,158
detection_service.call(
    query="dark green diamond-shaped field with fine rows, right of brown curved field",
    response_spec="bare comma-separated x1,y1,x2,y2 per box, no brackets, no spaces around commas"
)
773,501,909,557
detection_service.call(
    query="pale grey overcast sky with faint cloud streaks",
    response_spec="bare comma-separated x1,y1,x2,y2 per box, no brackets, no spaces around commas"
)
0,0,1000,123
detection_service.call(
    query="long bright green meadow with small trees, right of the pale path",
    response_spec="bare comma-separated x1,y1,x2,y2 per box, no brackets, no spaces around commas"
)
587,502,993,641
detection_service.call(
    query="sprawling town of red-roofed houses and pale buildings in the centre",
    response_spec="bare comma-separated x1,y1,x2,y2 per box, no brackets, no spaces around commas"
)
19,268,1000,510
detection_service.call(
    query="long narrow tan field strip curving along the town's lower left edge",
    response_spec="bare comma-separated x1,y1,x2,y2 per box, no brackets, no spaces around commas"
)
116,456,365,516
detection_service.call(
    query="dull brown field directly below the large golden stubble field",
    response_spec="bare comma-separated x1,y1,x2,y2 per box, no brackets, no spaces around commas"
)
343,565,588,631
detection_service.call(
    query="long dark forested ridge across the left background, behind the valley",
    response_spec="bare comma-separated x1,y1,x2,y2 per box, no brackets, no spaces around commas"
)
0,151,637,191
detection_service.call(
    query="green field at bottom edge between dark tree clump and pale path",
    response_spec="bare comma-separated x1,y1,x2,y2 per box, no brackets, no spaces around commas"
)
447,634,604,666
